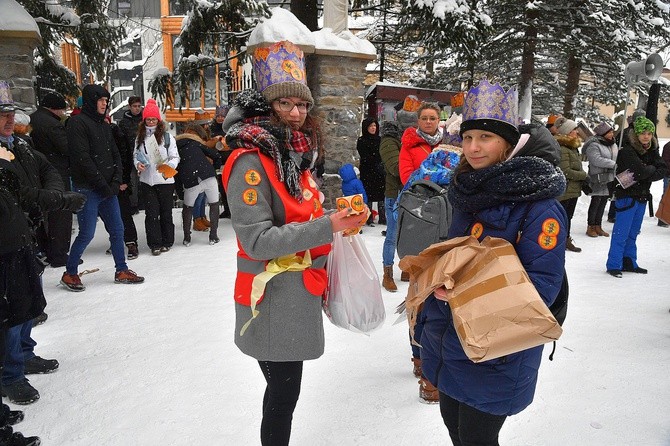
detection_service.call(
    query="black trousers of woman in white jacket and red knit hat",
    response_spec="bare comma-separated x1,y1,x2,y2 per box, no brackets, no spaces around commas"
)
140,183,174,249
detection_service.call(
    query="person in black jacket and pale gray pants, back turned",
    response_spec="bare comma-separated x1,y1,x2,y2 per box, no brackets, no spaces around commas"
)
177,123,221,246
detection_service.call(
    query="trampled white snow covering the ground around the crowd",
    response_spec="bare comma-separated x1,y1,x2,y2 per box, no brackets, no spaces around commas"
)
11,165,670,446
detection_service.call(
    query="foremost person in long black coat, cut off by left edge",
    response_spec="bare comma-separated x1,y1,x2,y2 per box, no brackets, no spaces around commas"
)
0,151,46,445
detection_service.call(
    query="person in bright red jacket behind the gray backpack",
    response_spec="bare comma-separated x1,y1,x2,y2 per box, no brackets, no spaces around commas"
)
398,102,442,184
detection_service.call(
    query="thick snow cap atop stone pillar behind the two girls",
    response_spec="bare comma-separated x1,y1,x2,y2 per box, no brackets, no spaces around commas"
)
247,7,377,59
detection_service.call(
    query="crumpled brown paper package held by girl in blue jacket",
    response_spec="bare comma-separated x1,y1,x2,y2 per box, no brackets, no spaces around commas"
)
400,237,562,362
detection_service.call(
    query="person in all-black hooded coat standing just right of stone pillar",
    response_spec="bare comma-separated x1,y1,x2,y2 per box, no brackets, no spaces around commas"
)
356,118,386,226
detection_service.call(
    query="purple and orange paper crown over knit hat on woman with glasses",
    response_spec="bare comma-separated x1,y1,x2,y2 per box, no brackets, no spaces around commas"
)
253,40,314,104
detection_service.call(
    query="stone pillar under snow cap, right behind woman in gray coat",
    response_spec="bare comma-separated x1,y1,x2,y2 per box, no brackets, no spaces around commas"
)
306,54,368,209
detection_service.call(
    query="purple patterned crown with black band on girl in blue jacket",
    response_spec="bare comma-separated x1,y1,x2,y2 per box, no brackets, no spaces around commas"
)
460,78,519,145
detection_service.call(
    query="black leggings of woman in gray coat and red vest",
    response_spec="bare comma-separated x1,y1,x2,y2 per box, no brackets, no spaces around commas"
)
258,361,302,446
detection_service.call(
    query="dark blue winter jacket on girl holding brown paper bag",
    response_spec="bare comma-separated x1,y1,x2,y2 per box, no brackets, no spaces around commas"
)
420,199,567,415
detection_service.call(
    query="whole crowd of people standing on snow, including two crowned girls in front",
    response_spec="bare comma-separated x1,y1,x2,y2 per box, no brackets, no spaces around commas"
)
0,33,670,445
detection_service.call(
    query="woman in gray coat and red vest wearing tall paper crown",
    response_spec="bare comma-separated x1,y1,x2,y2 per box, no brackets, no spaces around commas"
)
223,42,368,445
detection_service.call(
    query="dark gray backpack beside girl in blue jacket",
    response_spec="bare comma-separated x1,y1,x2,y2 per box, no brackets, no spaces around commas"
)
396,180,453,259
